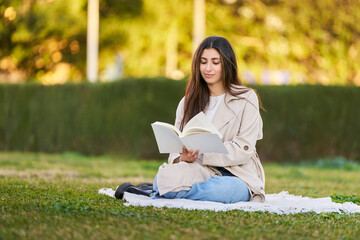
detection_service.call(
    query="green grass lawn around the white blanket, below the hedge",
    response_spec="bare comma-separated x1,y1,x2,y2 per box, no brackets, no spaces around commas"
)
0,153,360,239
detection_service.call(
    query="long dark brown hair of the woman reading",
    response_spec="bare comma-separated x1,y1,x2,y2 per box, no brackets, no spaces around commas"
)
180,36,258,130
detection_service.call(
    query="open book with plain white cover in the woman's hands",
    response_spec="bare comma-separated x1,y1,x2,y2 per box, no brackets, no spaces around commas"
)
151,112,228,154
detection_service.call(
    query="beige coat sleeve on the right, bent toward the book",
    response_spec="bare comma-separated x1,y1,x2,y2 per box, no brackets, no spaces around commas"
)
203,91,262,167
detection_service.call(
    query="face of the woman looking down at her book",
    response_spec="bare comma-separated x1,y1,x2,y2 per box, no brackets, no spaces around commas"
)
200,48,222,87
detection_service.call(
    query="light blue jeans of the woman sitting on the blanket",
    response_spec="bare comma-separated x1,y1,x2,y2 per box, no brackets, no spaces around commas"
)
153,169,251,203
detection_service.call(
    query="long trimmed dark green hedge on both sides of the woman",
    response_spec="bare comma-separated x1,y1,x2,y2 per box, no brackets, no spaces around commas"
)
0,79,360,161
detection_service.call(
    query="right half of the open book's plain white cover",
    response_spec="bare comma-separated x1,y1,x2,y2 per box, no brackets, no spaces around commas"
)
180,133,229,154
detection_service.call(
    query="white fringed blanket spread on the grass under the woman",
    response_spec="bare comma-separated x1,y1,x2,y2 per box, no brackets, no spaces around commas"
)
99,188,360,214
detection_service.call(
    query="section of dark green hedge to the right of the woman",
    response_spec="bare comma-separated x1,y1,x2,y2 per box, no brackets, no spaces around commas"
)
256,85,360,161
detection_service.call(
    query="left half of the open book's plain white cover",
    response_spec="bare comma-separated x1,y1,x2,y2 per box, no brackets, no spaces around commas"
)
151,122,183,153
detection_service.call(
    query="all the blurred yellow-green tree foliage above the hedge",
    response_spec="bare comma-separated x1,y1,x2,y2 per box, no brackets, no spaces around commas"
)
0,0,360,85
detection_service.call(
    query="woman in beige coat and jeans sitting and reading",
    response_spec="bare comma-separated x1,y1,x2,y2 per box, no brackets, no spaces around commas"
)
116,36,265,203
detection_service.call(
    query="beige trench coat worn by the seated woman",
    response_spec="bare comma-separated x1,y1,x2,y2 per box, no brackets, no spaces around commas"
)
157,86,265,202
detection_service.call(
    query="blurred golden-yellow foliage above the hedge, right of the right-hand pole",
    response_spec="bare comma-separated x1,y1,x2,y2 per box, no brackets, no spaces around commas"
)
207,0,360,85
